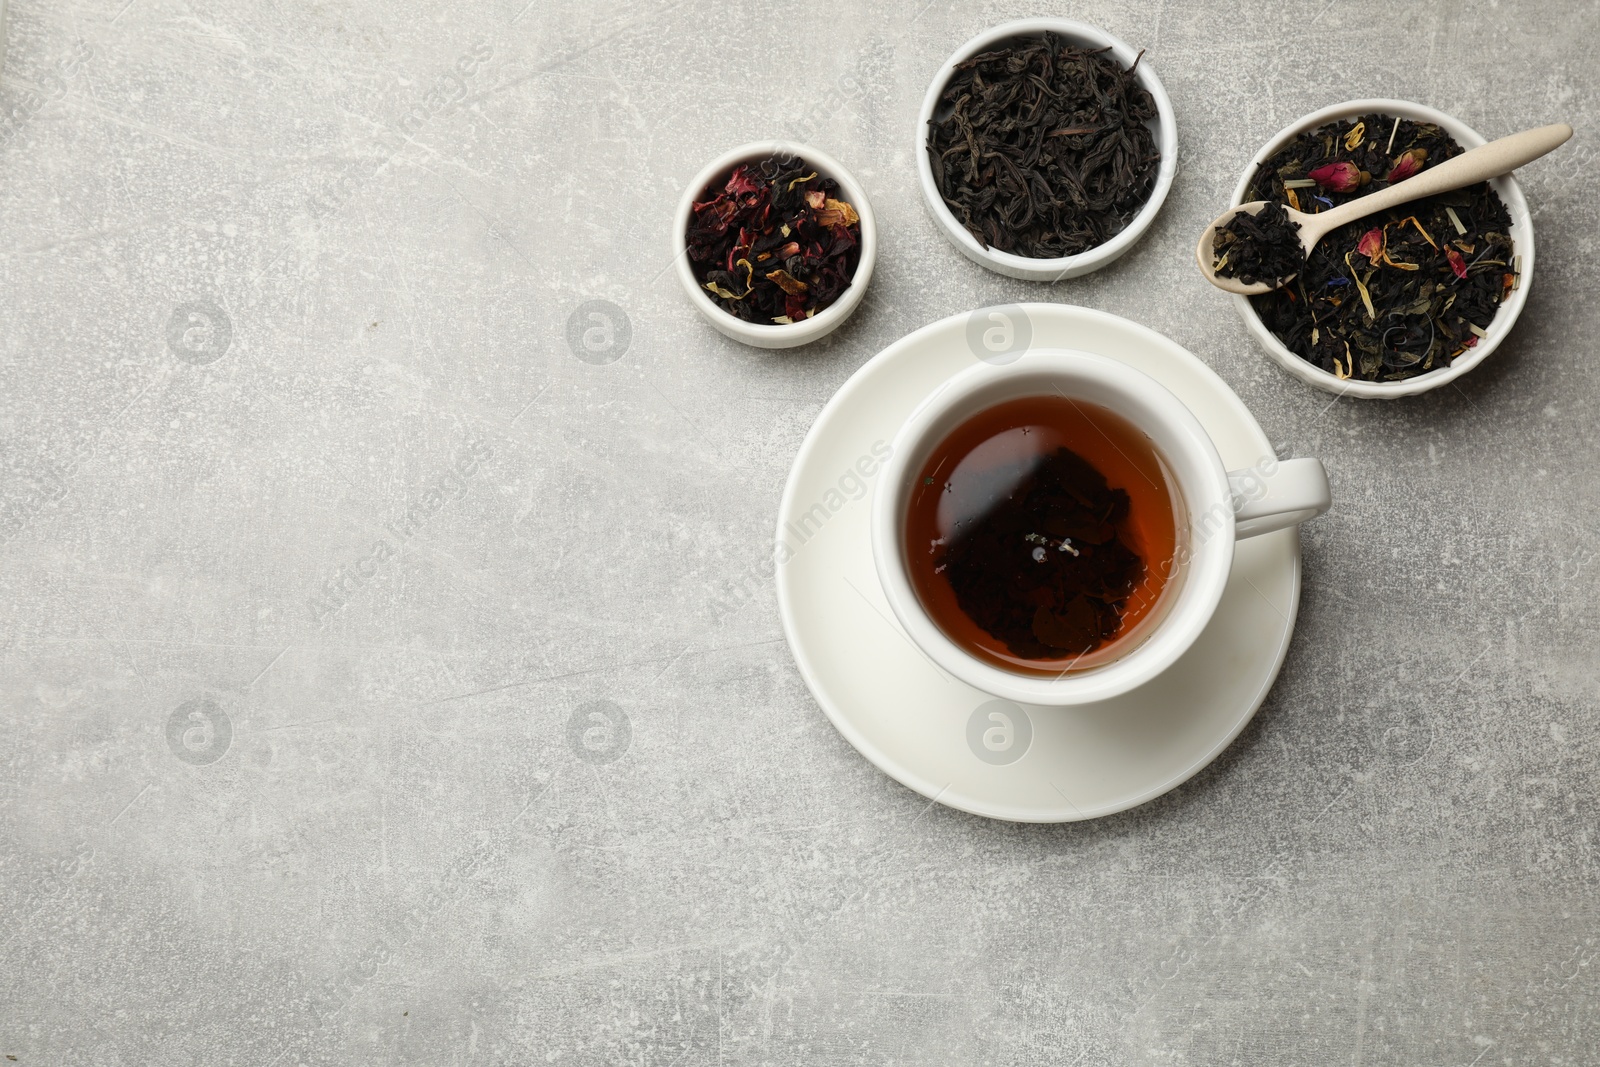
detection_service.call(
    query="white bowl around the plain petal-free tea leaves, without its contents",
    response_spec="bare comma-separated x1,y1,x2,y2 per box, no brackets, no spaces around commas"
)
915,18,1178,282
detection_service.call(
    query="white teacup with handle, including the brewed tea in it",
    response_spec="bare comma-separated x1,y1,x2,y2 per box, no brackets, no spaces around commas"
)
872,350,1330,704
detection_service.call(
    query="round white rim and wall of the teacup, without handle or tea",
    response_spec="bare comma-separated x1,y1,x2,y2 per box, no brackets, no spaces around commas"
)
870,349,1235,705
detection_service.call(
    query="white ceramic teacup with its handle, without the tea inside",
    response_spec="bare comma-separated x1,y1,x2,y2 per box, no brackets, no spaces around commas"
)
872,349,1330,705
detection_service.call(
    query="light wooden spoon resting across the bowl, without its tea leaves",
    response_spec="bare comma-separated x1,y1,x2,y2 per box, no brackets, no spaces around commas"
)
1195,123,1573,296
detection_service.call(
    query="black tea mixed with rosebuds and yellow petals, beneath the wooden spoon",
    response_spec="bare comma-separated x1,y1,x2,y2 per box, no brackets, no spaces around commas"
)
1245,115,1517,381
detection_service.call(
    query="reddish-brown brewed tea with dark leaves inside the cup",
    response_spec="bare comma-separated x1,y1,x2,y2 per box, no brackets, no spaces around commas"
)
904,394,1181,673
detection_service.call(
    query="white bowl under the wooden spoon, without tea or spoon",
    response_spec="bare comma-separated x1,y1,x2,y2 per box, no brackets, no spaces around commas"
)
1230,99,1533,400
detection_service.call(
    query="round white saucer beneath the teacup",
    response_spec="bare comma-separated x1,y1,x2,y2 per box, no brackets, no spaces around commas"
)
778,304,1299,822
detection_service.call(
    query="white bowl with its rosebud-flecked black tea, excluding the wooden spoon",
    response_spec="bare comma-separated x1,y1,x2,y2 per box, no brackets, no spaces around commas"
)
1232,99,1533,398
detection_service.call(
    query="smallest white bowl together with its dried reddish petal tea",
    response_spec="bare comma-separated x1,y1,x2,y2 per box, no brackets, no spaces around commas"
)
674,141,878,349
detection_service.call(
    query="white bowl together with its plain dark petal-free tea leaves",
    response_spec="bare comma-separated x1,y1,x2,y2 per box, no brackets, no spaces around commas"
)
915,18,1178,282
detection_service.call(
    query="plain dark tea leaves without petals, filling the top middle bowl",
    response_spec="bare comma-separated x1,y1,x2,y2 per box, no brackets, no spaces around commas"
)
926,34,1160,259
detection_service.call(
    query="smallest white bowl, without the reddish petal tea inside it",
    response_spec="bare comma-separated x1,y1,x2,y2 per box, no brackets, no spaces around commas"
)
672,141,878,349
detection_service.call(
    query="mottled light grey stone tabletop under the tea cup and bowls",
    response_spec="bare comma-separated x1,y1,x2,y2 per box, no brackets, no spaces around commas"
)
0,0,1600,1067
